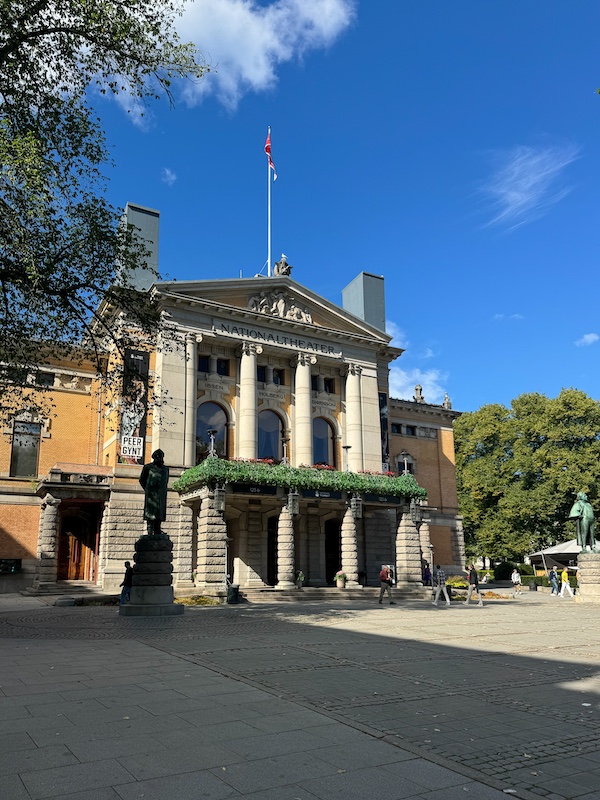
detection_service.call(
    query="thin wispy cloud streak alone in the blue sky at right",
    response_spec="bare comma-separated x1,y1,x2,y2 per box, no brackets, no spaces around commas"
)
481,144,579,229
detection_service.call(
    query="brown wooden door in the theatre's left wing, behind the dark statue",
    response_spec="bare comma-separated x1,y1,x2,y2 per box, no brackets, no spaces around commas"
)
57,509,99,581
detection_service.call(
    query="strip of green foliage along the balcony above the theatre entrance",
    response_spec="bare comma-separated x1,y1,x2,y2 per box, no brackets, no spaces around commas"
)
173,458,427,499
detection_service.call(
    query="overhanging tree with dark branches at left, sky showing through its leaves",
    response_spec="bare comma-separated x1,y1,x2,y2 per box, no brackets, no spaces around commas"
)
0,0,208,417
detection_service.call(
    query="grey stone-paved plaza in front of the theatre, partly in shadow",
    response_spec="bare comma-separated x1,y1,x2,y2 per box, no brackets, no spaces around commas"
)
0,592,600,800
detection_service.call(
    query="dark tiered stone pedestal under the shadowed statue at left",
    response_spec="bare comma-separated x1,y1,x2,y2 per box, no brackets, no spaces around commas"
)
119,533,184,617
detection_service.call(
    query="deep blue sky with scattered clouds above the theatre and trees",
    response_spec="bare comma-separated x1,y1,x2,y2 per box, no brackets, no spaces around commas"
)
94,0,600,411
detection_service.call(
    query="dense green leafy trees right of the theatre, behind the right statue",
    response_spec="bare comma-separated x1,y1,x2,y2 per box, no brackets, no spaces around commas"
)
454,389,600,559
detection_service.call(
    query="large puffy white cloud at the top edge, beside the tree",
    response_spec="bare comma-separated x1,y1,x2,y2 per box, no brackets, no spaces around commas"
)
178,0,356,109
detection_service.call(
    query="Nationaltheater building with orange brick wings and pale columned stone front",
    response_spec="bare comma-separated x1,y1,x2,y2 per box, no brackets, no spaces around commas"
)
0,259,464,594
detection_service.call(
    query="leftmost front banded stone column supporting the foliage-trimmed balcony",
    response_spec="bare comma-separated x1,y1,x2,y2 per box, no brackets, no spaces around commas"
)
196,488,227,594
